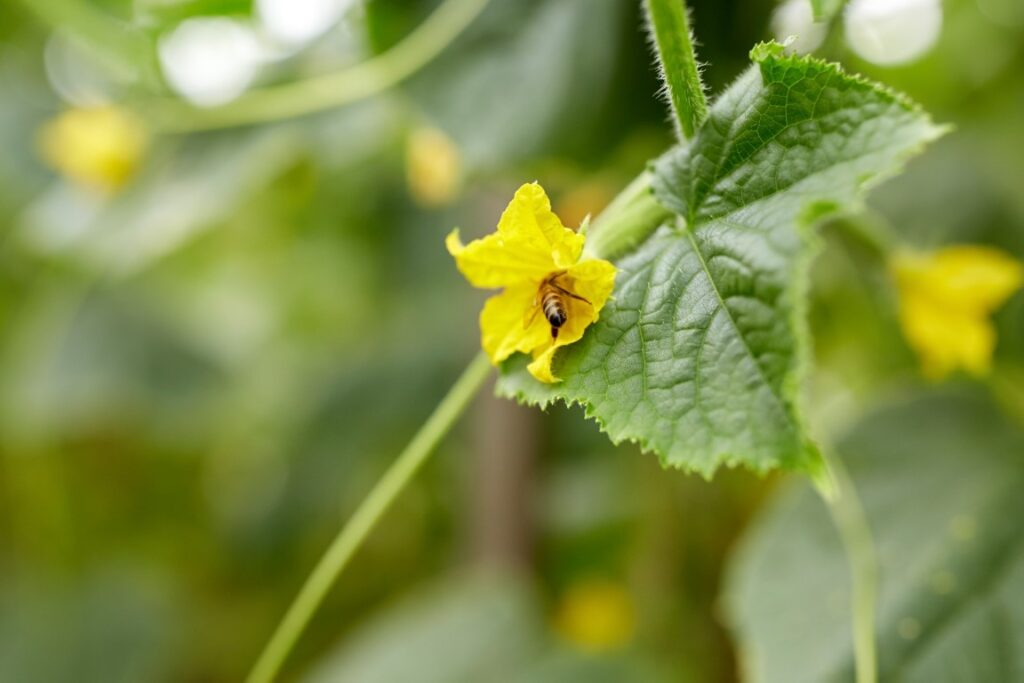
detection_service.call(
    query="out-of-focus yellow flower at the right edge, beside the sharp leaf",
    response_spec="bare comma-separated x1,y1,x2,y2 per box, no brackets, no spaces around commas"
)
893,246,1024,380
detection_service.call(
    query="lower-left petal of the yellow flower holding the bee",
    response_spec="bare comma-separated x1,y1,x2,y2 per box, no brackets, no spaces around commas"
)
480,285,551,365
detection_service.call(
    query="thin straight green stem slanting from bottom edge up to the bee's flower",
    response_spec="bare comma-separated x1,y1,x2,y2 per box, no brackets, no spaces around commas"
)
247,353,490,683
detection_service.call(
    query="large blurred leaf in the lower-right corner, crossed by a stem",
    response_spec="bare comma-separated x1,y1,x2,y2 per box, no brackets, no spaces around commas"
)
726,393,1024,683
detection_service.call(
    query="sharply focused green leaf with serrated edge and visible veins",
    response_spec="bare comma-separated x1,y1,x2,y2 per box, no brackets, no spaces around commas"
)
499,44,941,476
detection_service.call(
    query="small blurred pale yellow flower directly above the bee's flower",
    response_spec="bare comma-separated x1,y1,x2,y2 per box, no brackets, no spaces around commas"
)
406,128,462,207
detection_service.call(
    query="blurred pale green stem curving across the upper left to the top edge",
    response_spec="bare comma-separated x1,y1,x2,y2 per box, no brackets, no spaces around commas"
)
147,0,487,132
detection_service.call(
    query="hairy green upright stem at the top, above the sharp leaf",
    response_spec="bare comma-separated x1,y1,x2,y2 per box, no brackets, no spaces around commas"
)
644,0,708,139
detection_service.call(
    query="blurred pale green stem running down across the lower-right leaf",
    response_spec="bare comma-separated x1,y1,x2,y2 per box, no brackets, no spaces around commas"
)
822,448,879,683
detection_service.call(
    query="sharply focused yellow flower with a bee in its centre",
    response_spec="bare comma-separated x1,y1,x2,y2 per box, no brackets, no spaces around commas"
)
445,182,615,382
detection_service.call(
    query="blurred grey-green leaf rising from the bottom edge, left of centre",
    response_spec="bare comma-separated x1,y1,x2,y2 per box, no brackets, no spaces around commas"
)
304,571,667,683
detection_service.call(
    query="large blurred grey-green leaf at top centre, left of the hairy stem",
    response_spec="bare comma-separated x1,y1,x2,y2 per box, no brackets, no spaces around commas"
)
371,0,635,172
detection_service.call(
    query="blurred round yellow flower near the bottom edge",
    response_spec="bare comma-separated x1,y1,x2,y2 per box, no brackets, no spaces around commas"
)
554,579,636,652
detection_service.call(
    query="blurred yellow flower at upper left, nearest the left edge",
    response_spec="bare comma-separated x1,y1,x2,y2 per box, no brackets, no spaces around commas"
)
39,106,148,193
